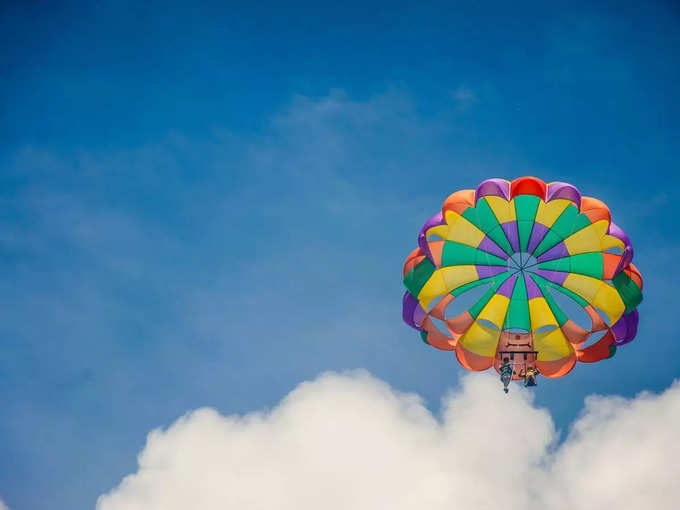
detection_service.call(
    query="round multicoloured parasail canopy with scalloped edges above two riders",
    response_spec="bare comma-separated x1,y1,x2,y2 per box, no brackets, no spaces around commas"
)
403,177,642,379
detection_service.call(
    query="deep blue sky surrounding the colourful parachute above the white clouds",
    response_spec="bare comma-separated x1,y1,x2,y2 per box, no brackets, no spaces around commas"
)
0,2,680,510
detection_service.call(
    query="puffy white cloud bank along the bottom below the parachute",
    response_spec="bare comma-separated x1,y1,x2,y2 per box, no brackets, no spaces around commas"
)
97,371,680,510
